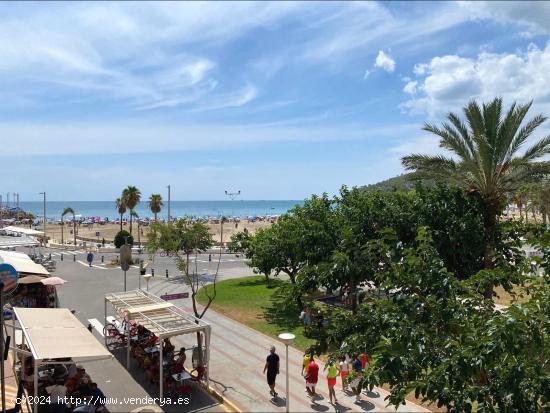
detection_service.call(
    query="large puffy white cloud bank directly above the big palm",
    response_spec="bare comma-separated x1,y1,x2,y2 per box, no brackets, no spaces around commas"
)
402,44,550,115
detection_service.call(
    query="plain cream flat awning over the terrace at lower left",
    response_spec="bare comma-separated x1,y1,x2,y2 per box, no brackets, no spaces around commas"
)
13,307,112,362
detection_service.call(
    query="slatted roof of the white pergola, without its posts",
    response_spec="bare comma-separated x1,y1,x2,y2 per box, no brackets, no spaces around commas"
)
105,290,210,338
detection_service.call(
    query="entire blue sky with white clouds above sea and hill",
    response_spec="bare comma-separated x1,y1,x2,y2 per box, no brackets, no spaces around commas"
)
0,1,550,201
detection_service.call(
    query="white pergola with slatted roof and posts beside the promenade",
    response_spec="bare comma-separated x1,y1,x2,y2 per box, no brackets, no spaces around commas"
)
105,290,211,399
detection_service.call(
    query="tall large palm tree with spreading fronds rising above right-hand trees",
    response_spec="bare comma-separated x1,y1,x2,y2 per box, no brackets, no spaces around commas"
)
402,98,550,290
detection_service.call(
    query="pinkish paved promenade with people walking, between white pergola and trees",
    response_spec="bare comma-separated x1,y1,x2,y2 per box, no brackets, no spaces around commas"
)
141,276,429,412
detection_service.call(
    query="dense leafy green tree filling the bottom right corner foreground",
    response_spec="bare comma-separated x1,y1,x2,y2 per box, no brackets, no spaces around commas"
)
330,229,550,412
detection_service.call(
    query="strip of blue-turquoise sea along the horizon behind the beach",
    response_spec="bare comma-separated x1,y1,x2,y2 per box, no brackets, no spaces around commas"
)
15,200,303,221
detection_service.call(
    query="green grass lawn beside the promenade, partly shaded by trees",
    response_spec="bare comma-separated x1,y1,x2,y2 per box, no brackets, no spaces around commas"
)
197,276,316,350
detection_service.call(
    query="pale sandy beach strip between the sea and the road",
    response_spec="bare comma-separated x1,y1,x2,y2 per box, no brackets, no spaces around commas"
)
36,220,272,243
